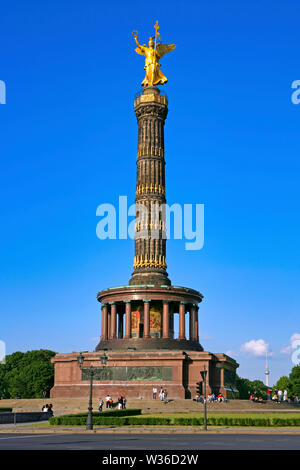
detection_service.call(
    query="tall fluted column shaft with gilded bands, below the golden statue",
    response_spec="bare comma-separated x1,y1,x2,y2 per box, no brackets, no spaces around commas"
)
129,86,171,285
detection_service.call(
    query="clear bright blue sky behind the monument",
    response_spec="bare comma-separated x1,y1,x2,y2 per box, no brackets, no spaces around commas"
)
0,0,300,382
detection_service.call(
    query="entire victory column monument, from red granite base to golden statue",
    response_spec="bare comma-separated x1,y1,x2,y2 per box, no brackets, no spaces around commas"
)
51,22,238,398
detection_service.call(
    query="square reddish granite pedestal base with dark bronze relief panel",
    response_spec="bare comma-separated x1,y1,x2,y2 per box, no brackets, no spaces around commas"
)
50,351,238,401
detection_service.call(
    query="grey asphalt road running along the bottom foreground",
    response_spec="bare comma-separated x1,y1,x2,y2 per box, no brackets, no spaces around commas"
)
0,433,300,451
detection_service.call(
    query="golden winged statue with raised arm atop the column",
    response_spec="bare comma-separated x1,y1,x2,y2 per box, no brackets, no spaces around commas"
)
132,22,176,87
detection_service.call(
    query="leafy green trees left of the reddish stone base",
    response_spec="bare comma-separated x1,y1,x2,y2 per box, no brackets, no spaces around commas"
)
0,349,55,398
